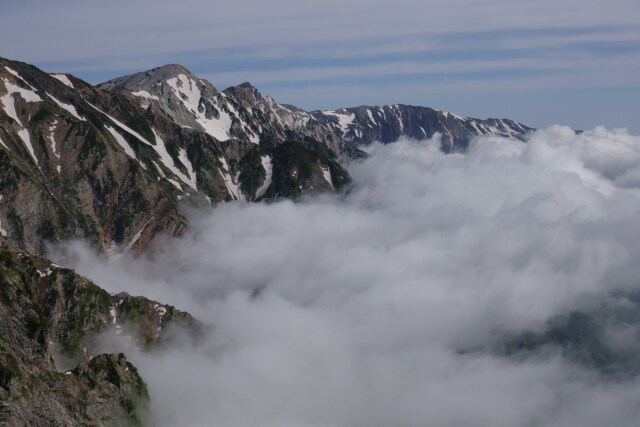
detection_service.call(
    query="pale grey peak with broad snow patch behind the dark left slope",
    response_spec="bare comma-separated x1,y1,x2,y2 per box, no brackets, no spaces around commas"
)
98,64,362,158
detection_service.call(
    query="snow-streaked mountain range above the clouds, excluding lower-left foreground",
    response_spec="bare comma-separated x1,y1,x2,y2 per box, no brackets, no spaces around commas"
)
0,59,531,254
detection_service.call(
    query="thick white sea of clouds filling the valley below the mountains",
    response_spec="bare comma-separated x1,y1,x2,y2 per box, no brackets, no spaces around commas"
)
51,126,640,427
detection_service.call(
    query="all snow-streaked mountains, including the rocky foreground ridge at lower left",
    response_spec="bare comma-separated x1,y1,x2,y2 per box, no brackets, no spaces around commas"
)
0,58,533,425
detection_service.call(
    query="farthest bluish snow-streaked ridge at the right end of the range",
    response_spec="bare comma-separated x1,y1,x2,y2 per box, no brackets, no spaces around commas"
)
311,104,533,152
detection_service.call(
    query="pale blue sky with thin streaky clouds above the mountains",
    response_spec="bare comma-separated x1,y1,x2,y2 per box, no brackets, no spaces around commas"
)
0,0,640,133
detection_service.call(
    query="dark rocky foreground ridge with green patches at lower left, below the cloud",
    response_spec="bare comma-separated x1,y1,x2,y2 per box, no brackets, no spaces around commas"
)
0,251,197,426
